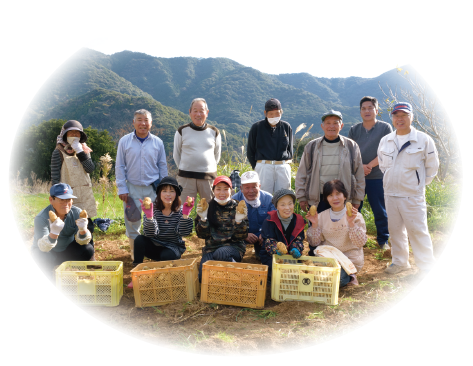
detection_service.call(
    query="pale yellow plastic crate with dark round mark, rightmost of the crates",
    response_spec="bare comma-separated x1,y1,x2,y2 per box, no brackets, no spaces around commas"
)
271,255,340,305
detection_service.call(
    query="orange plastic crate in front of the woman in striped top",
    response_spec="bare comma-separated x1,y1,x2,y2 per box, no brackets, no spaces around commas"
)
131,258,200,307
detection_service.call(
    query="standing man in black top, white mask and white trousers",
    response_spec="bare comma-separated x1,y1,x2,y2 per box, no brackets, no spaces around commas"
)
247,98,292,194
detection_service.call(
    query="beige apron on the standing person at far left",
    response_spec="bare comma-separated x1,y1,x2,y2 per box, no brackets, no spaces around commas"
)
59,150,97,217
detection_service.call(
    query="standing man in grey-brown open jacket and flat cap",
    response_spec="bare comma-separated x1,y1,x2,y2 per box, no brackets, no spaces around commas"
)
296,110,365,213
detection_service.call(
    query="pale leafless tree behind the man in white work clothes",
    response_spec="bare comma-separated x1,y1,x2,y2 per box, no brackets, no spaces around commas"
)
379,67,461,180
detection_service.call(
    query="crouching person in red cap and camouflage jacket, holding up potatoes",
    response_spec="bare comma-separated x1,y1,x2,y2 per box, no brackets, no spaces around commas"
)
195,176,248,282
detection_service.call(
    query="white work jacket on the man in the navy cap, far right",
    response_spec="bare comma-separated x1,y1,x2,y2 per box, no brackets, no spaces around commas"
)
378,126,439,197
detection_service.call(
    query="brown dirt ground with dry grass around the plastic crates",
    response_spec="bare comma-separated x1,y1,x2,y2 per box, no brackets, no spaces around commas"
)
20,229,450,356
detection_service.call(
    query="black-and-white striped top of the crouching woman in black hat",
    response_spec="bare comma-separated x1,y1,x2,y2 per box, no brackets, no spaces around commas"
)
143,209,193,257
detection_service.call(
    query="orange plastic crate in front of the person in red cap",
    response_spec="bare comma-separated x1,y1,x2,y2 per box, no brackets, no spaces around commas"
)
200,261,268,309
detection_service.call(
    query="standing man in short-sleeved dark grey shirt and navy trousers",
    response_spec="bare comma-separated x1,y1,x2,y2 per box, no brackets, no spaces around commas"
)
348,97,393,249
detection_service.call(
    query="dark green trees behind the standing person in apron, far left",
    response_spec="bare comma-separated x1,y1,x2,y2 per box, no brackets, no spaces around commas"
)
8,119,117,181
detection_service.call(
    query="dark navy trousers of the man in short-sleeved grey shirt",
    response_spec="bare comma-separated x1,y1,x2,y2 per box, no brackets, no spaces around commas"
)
358,179,389,246
